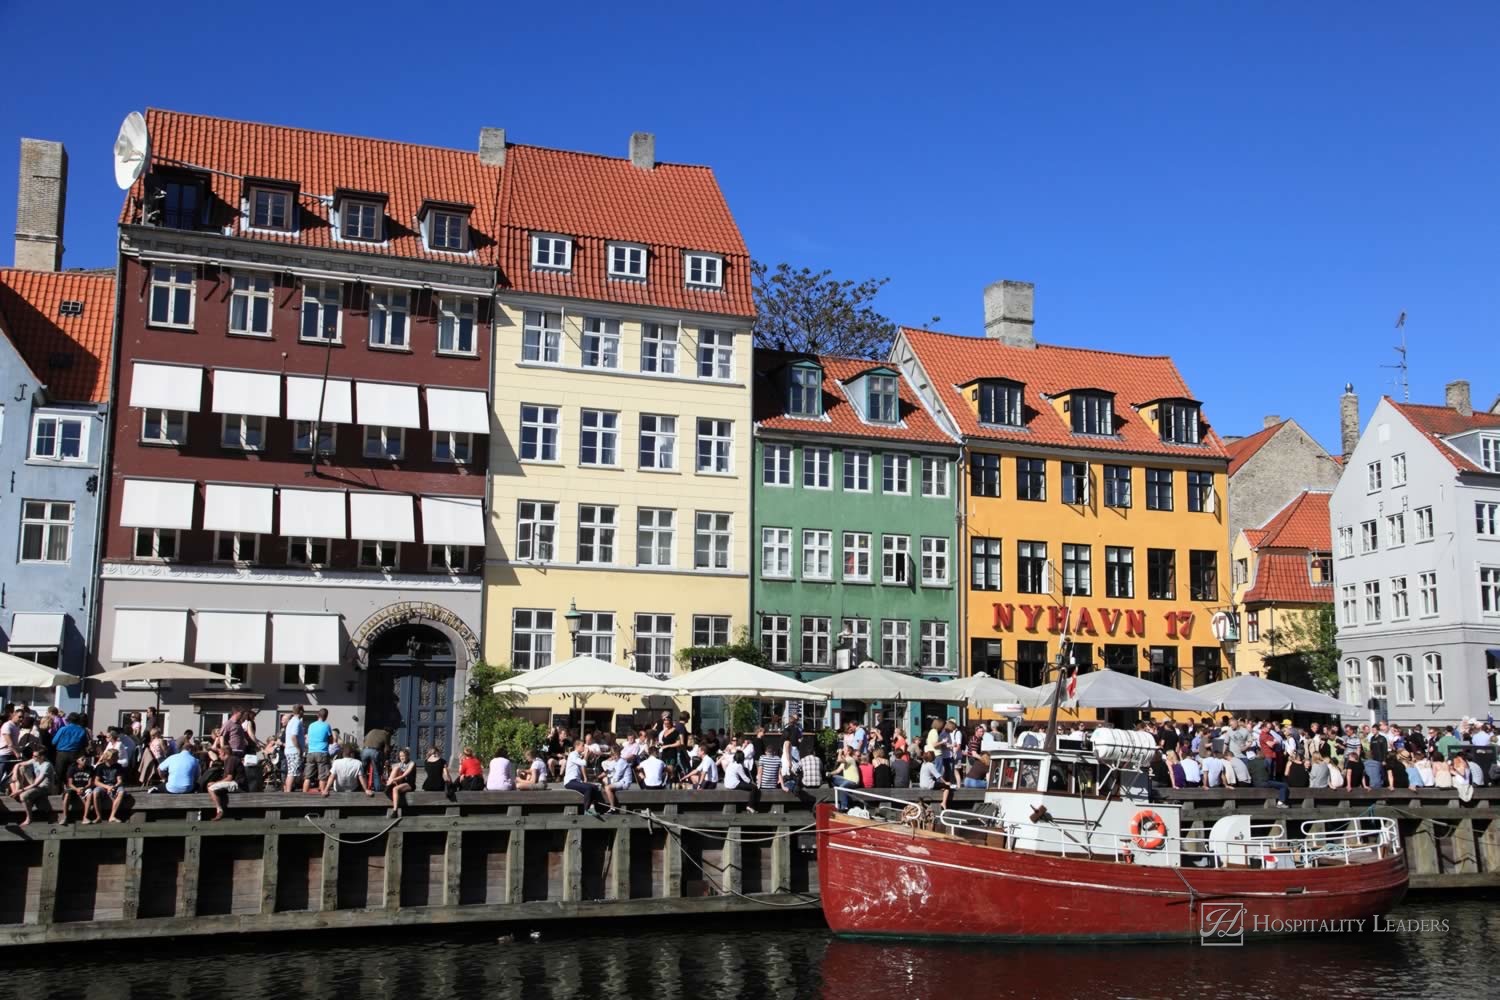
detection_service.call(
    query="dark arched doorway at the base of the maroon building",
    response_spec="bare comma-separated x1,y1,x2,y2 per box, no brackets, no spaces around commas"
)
365,625,458,760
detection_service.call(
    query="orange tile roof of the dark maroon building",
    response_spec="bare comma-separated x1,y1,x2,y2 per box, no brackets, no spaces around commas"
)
120,108,501,267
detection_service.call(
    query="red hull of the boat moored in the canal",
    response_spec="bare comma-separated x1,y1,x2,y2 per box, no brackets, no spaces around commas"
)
818,805,1407,943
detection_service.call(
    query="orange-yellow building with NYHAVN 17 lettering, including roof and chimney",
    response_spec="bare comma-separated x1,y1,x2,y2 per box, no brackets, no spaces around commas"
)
893,282,1230,710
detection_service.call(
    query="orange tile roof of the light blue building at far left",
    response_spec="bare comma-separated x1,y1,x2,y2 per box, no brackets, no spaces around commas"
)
0,268,114,403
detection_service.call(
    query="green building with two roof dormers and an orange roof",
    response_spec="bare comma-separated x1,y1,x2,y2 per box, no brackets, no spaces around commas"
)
752,351,963,732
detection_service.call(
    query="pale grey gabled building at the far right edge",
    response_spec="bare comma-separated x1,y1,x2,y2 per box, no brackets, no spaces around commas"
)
1329,382,1500,723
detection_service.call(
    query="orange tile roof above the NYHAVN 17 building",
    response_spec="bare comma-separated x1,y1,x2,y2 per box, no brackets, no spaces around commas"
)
902,327,1229,459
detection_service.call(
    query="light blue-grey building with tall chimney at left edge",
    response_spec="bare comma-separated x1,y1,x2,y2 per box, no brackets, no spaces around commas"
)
0,139,116,709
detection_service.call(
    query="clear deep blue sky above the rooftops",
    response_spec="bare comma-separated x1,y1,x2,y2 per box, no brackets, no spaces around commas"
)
0,0,1500,447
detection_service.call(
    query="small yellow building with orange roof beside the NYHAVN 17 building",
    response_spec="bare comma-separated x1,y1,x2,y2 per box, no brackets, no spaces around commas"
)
1230,490,1334,684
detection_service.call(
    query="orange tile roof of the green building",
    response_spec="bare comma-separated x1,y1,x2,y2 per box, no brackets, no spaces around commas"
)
755,349,957,445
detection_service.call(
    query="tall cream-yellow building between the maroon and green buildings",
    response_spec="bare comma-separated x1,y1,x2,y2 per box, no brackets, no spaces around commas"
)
485,133,755,729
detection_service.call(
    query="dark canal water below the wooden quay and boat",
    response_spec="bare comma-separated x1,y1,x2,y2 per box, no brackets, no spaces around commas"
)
11,897,1500,1000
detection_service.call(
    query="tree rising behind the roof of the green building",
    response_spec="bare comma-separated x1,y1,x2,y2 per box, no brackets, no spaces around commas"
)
750,261,896,360
